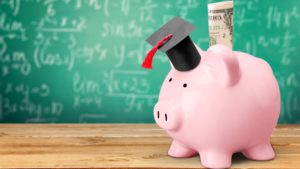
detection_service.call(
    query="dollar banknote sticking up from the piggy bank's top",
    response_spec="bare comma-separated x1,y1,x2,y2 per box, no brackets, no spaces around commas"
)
208,1,233,48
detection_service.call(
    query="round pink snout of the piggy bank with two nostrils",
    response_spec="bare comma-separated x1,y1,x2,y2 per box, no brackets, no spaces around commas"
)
153,101,182,130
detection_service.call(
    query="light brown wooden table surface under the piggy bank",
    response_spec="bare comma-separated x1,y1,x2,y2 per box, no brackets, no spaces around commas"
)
0,124,300,169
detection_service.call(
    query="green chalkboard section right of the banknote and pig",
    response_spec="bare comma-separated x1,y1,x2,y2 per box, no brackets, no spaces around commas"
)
233,0,300,123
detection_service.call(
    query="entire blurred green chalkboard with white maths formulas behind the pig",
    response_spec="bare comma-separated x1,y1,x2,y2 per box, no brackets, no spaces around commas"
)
0,0,300,123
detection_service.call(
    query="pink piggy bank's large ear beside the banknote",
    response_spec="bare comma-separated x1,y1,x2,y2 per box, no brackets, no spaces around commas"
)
203,45,241,86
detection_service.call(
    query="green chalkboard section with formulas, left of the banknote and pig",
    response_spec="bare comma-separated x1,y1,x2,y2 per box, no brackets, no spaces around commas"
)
0,0,208,123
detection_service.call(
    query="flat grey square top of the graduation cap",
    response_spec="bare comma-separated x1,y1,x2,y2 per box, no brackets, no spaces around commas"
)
146,16,195,52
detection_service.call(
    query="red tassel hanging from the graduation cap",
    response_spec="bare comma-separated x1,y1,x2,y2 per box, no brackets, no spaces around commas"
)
142,34,173,69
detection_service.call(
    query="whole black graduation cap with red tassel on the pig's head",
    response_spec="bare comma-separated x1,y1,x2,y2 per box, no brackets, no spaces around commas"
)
142,17,201,71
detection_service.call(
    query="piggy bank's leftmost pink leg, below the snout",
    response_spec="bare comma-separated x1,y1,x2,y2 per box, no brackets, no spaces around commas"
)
168,140,197,157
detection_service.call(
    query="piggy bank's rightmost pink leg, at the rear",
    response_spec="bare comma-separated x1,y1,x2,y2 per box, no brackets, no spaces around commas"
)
242,143,275,160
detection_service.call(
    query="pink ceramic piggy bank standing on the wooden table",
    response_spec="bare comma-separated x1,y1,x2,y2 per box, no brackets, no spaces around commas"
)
153,45,280,168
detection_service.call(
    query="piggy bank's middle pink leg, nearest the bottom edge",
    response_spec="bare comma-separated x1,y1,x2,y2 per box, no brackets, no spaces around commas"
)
200,150,232,168
